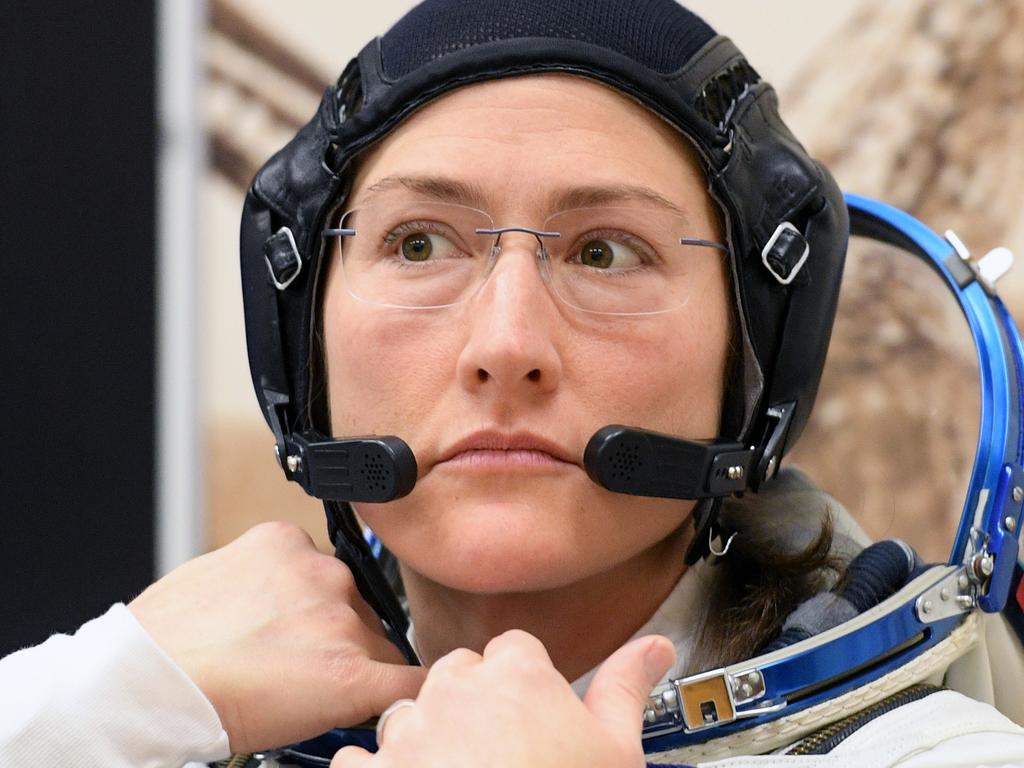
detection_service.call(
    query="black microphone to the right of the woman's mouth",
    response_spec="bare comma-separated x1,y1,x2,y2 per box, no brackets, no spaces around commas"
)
584,424,754,499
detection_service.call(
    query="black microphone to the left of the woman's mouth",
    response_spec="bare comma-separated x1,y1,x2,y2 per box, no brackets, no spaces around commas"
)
282,432,417,504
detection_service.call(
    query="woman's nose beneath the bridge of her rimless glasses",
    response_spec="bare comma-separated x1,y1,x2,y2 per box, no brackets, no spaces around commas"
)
457,232,563,399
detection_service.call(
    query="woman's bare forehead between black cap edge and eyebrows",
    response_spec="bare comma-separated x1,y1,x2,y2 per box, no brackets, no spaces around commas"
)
352,75,707,218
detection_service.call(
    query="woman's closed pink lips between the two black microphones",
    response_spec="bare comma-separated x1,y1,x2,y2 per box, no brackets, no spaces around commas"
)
437,430,580,470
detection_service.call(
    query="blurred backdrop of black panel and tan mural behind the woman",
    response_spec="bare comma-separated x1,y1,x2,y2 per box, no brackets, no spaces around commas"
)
0,0,1024,654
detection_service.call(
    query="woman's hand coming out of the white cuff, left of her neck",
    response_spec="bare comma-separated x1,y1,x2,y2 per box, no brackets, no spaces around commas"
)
128,523,426,752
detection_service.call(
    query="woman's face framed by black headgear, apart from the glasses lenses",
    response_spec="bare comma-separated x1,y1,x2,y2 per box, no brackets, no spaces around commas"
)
324,76,729,593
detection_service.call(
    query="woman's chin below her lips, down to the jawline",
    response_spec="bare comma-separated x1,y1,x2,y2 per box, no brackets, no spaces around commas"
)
359,478,689,594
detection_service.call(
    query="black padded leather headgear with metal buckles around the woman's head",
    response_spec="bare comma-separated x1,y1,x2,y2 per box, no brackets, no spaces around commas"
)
242,0,848,512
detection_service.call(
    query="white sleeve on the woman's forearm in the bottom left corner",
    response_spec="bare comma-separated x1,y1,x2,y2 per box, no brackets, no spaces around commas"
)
0,603,229,768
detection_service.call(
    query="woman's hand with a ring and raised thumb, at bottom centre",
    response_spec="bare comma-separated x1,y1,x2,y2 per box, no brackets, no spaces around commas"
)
331,631,675,768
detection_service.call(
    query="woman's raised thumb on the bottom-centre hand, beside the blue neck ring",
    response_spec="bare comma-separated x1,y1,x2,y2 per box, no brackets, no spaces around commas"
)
584,635,676,739
